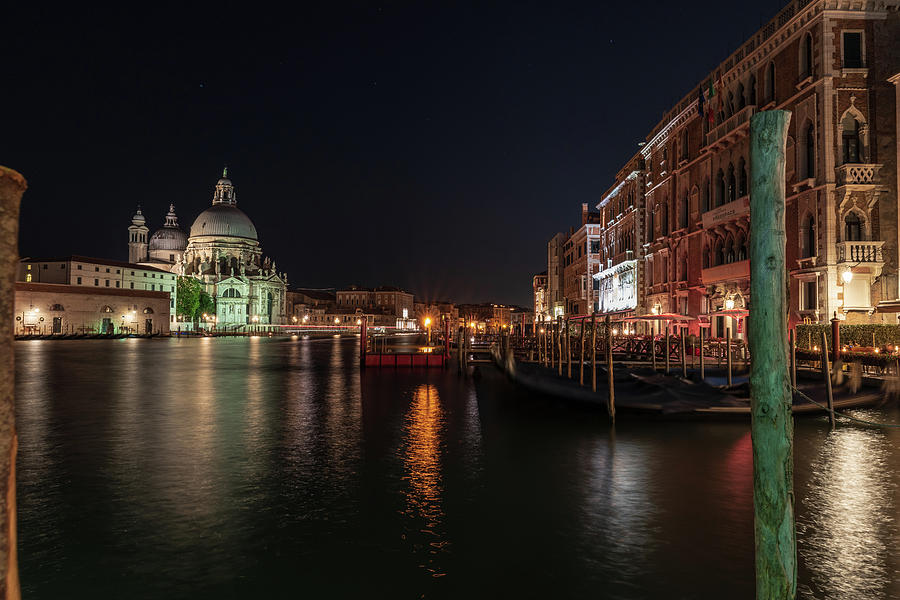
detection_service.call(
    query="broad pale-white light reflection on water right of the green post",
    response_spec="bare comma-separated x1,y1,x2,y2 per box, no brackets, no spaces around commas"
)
799,427,896,599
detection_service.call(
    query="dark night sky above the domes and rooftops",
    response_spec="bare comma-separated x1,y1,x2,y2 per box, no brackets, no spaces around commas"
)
0,0,786,306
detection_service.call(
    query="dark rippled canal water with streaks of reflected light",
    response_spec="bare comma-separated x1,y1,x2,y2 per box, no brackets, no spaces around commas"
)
16,338,900,600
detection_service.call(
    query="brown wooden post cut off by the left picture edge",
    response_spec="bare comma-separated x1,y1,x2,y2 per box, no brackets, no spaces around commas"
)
0,167,28,600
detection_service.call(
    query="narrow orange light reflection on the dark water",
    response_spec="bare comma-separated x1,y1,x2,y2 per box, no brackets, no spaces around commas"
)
403,384,448,577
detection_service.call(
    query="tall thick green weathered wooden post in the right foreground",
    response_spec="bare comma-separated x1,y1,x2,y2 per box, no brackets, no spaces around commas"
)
748,110,797,600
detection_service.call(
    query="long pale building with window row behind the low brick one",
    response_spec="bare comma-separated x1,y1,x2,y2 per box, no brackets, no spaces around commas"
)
18,256,178,322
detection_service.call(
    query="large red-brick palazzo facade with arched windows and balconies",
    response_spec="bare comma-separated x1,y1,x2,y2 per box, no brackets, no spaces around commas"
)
584,0,900,337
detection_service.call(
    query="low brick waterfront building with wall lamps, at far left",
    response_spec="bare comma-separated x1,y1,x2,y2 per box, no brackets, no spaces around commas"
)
13,282,171,335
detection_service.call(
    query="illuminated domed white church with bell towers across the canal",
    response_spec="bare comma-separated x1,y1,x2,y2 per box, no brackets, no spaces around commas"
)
128,168,287,329
